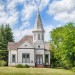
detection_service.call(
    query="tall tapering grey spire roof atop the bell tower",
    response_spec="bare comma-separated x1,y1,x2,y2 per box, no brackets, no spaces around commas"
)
33,11,45,32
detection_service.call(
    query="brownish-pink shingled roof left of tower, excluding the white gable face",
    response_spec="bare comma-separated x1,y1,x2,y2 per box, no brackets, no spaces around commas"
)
8,35,33,50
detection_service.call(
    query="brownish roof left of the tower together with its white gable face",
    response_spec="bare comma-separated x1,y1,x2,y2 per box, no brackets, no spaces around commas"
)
8,35,33,50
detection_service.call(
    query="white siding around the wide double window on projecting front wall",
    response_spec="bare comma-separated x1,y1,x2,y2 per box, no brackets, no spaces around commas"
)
17,49,35,66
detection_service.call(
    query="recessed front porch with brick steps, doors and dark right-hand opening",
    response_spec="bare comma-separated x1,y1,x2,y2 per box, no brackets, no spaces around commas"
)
35,54,50,68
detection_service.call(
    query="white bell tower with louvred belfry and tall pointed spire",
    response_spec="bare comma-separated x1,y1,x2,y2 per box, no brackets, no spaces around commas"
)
33,11,45,46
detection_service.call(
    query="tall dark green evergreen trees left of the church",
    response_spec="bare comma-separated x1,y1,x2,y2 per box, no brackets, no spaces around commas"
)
0,24,14,62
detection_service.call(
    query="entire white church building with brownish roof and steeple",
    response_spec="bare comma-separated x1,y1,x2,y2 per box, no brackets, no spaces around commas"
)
8,13,50,66
